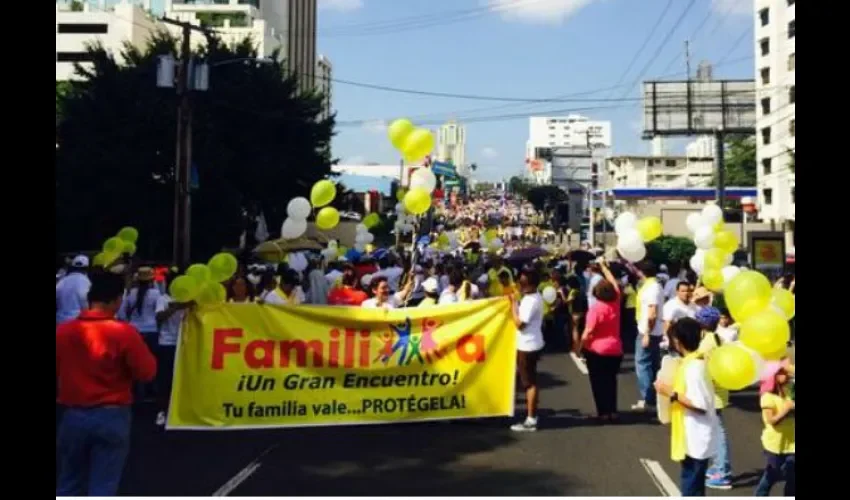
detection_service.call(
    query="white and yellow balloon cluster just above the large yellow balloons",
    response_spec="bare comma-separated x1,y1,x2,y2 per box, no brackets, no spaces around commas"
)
685,205,741,292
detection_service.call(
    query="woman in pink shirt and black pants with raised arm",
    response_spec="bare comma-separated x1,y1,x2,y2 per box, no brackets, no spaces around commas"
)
581,259,623,421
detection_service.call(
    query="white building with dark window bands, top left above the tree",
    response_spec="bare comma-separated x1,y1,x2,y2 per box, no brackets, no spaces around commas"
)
56,0,164,81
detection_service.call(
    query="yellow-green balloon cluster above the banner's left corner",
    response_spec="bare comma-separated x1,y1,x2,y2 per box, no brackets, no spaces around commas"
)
168,252,239,305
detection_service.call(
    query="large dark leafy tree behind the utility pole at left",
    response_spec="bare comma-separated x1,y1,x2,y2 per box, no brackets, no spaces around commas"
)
56,33,334,259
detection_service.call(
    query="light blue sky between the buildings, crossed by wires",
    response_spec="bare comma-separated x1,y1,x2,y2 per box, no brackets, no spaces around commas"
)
318,0,754,179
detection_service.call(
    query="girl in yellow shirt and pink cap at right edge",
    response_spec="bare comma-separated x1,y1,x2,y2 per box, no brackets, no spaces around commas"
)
756,361,797,497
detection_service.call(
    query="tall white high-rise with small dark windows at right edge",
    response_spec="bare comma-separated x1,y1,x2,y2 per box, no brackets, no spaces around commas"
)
754,0,796,248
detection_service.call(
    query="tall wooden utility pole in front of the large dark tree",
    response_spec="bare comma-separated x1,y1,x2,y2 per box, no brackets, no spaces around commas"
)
161,17,207,269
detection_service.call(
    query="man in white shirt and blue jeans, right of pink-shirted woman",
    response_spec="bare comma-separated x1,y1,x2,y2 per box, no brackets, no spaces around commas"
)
632,260,664,411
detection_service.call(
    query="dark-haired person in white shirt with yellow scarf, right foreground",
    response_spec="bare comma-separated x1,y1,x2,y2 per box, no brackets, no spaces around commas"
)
655,318,720,497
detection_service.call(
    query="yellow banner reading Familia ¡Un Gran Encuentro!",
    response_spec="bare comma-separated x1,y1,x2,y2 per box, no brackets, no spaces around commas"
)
163,298,516,430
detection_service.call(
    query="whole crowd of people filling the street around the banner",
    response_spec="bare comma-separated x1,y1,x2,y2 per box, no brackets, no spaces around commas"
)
56,194,795,496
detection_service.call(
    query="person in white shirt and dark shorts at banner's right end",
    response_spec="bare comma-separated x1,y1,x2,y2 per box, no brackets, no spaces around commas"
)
511,270,546,432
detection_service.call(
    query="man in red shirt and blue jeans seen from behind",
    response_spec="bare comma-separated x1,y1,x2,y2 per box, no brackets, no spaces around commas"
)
56,272,156,496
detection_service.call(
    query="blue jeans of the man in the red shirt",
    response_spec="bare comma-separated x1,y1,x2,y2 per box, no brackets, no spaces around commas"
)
56,406,130,496
